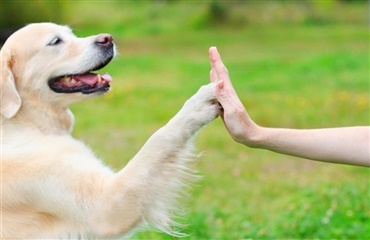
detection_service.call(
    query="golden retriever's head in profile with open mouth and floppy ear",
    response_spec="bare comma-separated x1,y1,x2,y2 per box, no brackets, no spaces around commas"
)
0,23,115,118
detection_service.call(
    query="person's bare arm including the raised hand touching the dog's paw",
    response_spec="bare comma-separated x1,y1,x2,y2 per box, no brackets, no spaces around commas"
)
209,47,370,166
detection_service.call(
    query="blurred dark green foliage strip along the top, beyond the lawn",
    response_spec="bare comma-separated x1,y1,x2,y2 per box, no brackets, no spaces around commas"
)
0,0,367,31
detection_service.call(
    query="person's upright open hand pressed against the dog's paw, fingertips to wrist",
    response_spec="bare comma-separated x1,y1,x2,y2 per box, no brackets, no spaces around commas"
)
209,47,258,146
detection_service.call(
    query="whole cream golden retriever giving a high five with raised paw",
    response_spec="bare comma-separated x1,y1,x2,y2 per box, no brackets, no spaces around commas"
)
0,23,220,239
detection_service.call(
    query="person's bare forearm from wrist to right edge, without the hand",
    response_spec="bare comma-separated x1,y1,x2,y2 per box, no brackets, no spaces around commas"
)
244,127,370,166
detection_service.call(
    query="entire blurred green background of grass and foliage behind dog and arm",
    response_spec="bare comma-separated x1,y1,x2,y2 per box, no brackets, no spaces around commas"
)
0,0,370,239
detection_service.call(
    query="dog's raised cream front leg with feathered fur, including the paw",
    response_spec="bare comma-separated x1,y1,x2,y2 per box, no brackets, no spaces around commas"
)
91,84,220,235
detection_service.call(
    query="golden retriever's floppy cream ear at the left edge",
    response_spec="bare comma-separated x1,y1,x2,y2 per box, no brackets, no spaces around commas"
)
0,49,22,118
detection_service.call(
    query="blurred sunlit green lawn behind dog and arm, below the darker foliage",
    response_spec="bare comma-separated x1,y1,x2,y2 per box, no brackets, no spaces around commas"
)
65,1,370,239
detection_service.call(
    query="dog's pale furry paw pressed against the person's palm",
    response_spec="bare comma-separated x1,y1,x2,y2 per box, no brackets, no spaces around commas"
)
183,83,221,126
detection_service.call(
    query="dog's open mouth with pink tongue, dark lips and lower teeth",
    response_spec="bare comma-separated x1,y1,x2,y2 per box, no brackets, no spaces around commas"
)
49,72,113,94
